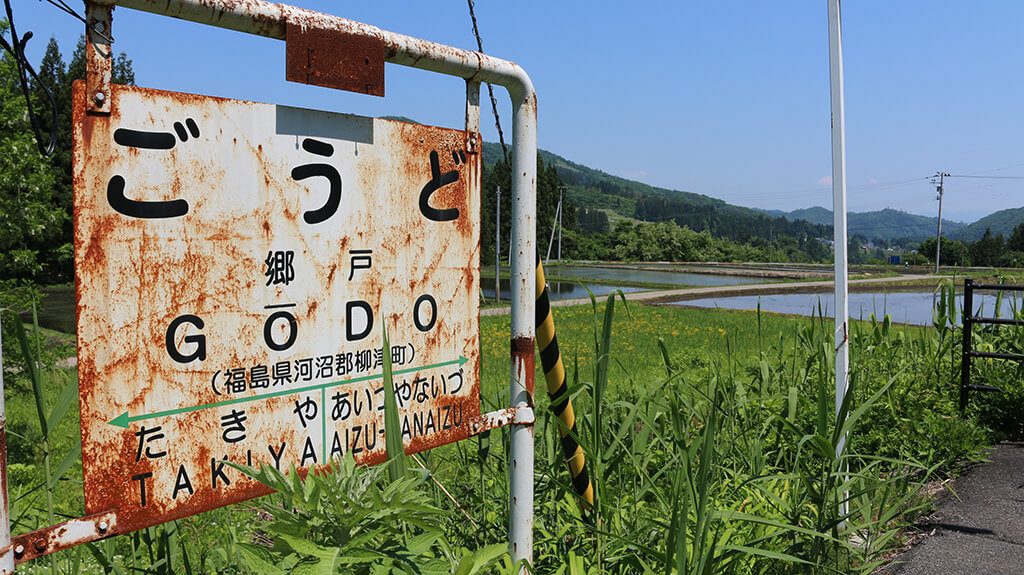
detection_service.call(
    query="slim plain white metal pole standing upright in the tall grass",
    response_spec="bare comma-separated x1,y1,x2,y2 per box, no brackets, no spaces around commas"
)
828,0,850,517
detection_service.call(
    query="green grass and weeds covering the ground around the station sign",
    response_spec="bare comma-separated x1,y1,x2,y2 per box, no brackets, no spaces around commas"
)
4,282,1024,575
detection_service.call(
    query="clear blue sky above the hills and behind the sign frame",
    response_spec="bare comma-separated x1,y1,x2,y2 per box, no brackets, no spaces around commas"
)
14,0,1024,221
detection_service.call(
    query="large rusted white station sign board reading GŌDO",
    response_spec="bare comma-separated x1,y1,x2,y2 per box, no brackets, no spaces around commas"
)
74,78,480,532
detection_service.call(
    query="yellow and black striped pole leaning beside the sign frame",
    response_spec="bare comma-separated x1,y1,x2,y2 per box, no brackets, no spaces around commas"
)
537,256,594,508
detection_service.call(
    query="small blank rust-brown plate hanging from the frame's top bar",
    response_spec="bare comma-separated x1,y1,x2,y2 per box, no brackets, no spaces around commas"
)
285,23,387,96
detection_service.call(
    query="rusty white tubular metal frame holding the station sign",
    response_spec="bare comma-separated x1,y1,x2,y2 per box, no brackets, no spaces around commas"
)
0,0,537,575
